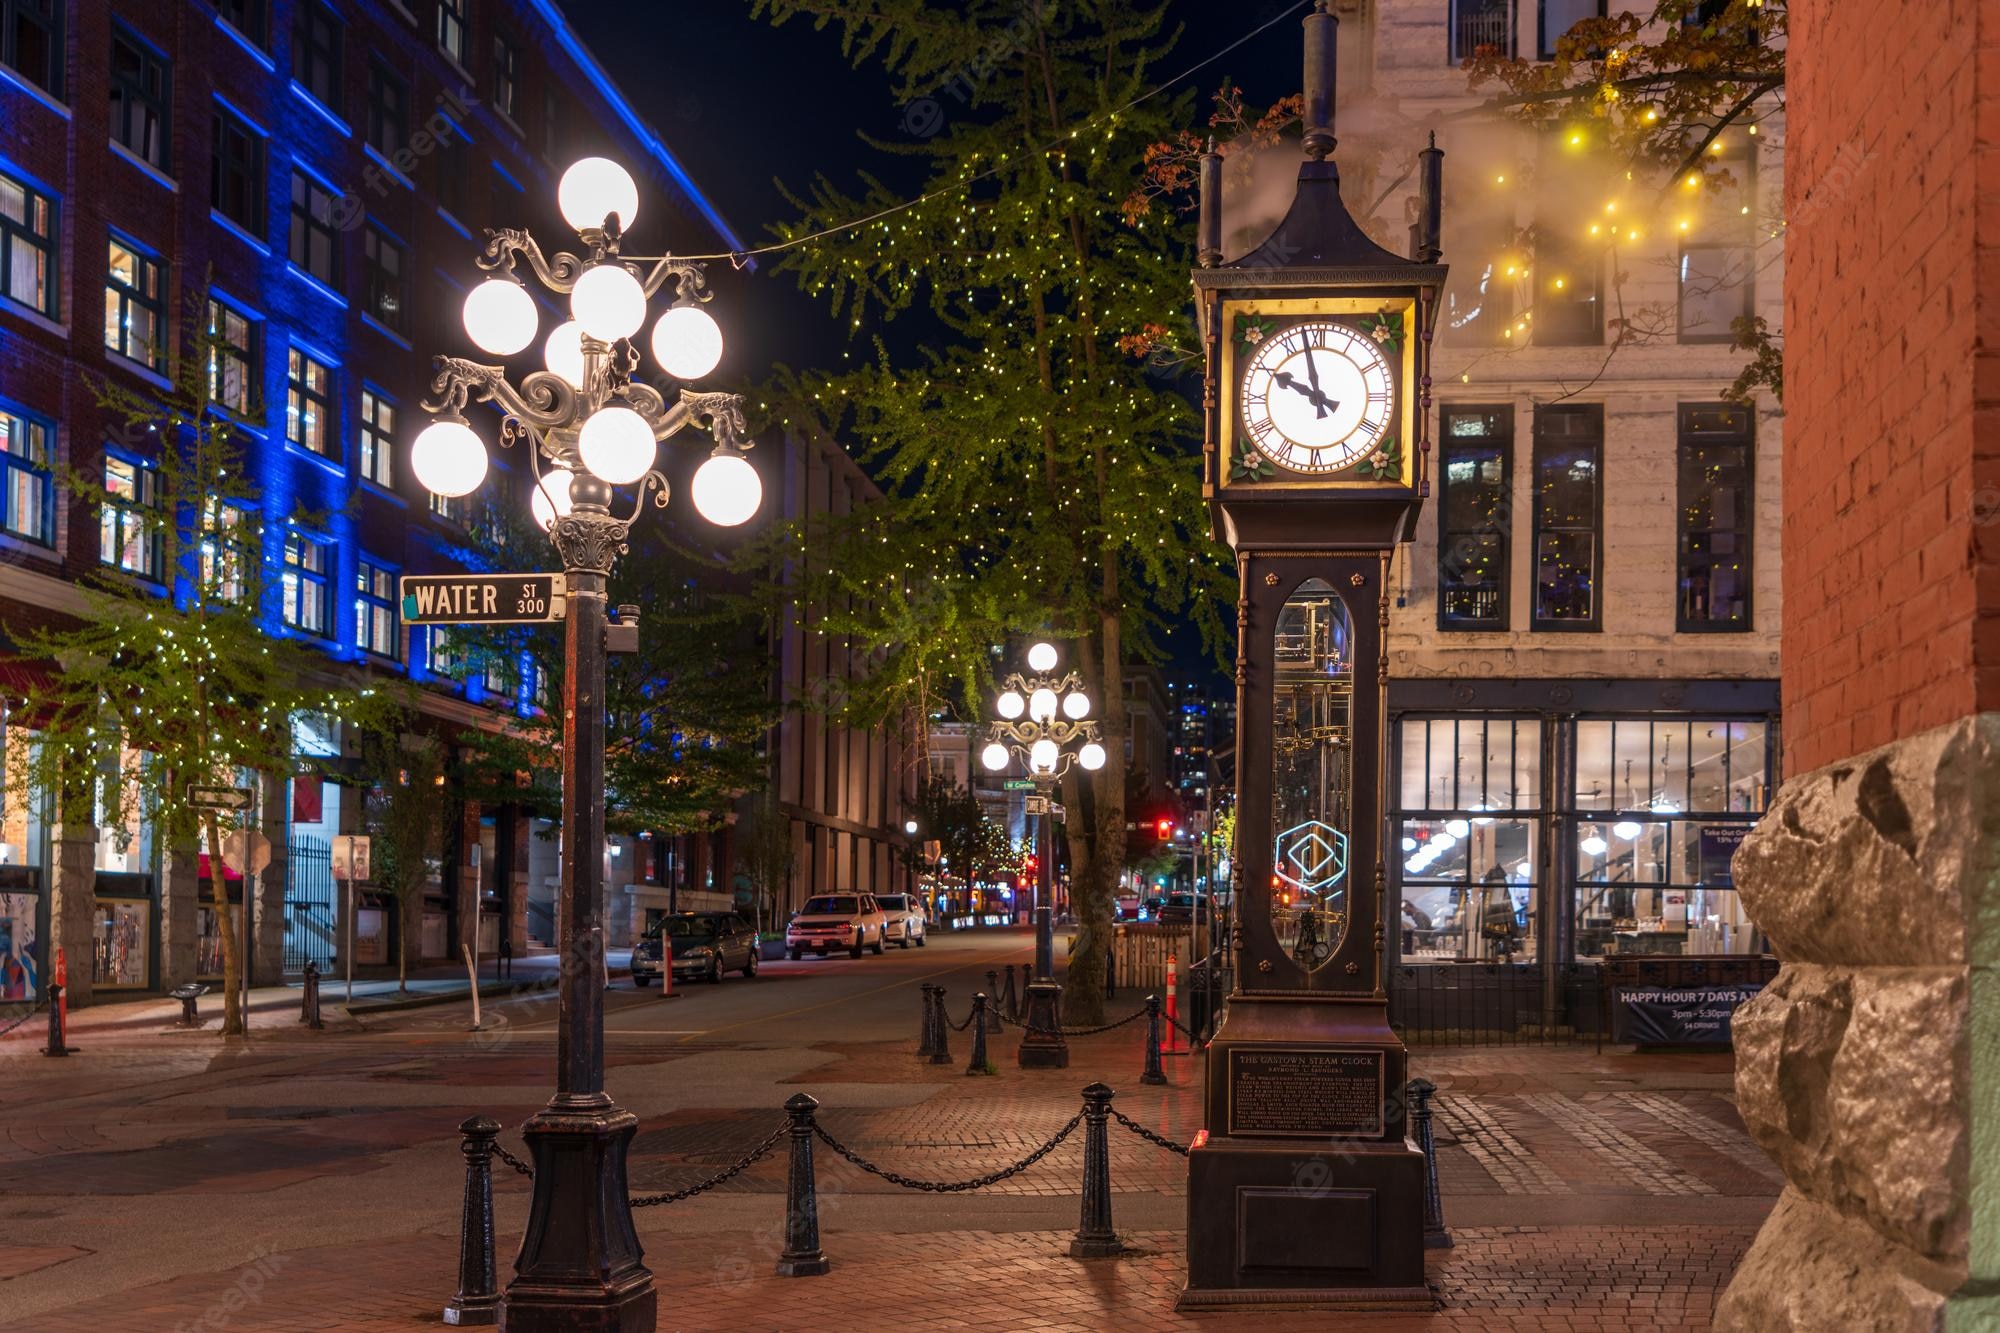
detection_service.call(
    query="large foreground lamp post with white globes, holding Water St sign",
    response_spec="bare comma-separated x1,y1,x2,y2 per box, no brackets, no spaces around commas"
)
410,158,762,1333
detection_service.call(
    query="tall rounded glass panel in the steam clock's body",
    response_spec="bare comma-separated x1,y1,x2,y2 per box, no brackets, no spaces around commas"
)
1270,578,1354,971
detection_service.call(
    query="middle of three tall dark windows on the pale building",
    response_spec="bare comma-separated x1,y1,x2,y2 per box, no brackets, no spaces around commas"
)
1532,404,1604,630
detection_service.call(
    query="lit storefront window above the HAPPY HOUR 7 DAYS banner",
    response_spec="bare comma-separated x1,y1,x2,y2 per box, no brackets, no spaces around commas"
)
1572,719,1770,957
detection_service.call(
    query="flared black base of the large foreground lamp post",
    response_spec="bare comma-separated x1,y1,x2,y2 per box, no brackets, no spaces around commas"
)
500,1099,658,1333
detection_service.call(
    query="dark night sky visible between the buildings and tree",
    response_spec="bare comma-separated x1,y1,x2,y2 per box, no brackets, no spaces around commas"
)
562,0,1304,683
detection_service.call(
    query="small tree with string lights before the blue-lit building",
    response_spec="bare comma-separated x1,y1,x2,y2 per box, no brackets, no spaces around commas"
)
10,298,390,1037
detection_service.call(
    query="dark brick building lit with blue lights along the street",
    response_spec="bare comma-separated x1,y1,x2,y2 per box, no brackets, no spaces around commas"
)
0,0,760,1001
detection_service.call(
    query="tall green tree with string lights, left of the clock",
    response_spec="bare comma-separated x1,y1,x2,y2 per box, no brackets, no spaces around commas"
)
752,0,1228,1021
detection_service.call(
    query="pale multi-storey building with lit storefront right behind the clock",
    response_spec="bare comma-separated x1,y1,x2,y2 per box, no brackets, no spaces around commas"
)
1226,0,1784,1023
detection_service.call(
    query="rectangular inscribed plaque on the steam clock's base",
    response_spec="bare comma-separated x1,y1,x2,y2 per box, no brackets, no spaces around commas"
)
1224,1047,1386,1139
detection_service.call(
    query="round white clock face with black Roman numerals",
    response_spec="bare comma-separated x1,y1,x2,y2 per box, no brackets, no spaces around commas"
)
1238,320,1396,472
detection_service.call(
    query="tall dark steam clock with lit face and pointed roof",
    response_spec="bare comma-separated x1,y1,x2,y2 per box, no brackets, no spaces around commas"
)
1180,0,1446,1311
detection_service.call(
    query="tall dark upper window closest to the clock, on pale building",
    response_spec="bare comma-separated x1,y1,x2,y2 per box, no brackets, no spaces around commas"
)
1438,406,1514,630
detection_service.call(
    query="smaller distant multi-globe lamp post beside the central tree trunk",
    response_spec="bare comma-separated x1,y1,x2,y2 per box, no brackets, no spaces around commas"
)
980,642,1104,1069
